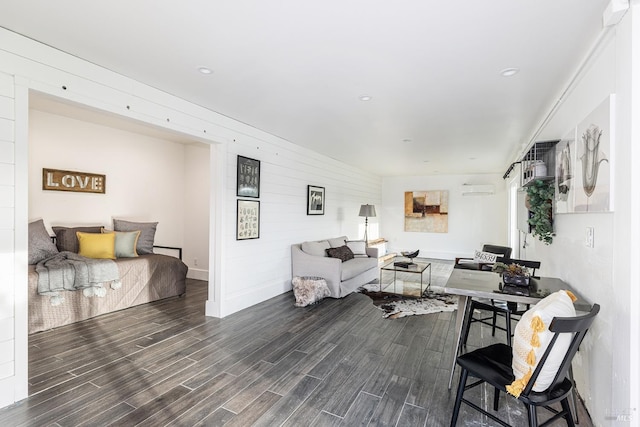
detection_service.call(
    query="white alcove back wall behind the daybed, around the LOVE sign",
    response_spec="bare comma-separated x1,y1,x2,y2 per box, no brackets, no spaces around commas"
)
29,109,186,247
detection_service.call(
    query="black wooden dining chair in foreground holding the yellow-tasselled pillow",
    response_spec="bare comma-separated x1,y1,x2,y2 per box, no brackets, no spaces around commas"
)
451,304,600,427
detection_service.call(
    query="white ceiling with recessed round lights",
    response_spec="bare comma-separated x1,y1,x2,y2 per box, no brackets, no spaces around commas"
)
0,0,607,176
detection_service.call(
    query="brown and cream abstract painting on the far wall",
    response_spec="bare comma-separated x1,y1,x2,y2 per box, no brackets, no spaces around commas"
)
404,190,449,233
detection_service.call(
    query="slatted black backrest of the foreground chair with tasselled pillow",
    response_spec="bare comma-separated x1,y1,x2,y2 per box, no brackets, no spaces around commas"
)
522,304,600,396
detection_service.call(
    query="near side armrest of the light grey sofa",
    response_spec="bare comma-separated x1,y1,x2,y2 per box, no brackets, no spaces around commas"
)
291,245,342,298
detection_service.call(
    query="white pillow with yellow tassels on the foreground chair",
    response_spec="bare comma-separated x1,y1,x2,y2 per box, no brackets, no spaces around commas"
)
507,291,576,397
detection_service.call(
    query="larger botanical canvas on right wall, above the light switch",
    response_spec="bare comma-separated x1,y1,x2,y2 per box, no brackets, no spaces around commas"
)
572,95,615,212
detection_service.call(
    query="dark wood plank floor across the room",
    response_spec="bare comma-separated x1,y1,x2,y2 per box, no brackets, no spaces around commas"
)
0,280,591,426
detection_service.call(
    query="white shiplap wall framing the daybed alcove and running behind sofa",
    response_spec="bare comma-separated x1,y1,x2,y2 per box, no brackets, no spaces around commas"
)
0,28,381,406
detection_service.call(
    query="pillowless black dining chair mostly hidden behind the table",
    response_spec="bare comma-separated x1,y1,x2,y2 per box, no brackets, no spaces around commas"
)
462,258,541,346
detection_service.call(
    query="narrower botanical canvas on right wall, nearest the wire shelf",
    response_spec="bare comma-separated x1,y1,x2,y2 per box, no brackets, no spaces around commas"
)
555,127,579,213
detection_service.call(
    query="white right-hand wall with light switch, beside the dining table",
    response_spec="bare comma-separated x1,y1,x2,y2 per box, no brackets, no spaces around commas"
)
521,7,640,426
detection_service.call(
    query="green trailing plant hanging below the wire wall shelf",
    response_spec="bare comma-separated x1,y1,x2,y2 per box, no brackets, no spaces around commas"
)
527,179,555,245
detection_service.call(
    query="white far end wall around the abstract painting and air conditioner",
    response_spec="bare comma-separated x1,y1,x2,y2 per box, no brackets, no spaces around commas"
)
378,174,507,259
